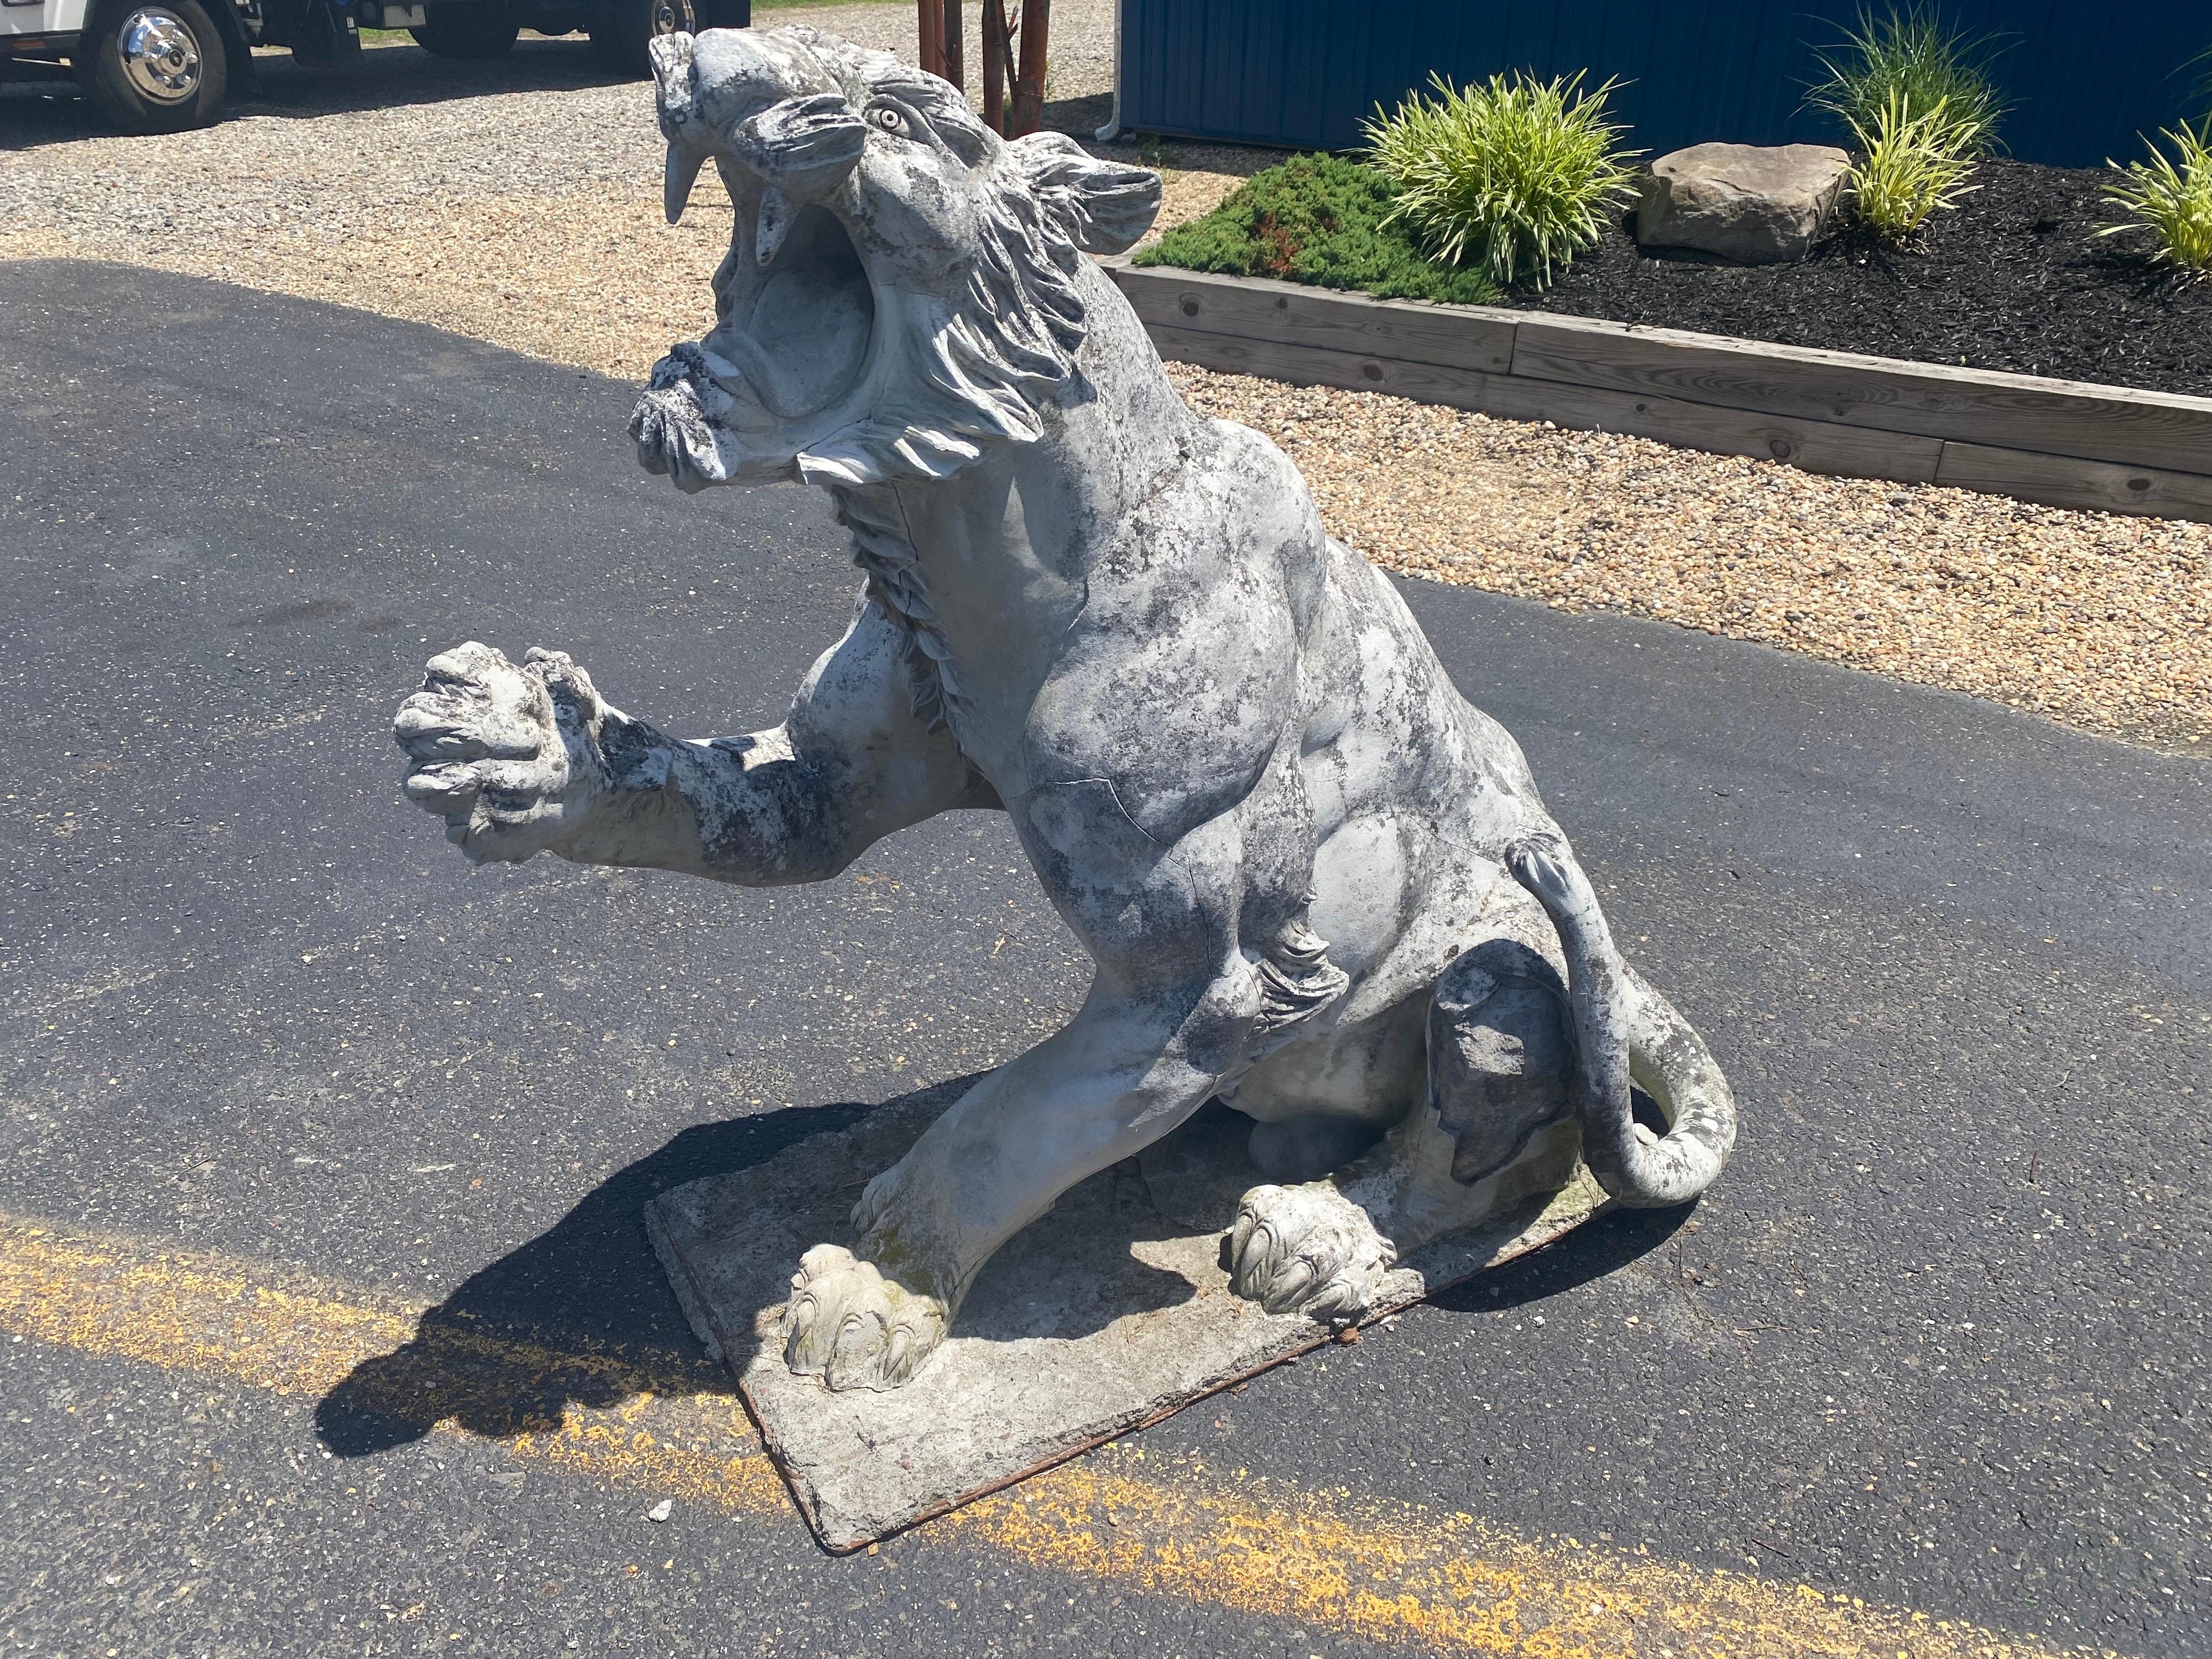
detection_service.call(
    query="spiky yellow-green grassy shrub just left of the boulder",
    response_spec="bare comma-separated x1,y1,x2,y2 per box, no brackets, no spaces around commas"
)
1365,73,1637,288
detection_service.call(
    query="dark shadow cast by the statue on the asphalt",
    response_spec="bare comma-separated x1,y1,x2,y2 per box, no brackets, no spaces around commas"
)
314,1077,1697,1458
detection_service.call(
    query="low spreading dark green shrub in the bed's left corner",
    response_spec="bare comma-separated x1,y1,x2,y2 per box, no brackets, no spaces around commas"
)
1137,155,1498,305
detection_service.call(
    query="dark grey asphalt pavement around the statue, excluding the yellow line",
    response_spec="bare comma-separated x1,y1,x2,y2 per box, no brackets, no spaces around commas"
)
0,263,2212,1659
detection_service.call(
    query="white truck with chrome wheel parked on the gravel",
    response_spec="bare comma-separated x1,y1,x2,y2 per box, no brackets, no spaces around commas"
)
0,0,752,133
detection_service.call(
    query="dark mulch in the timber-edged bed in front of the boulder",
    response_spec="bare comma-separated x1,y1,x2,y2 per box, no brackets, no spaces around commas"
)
1506,161,2212,396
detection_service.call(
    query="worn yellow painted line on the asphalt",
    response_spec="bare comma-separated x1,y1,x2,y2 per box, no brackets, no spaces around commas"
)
0,1214,2106,1659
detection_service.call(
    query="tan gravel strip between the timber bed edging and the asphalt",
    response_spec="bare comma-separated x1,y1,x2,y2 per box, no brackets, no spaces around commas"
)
1170,363,2212,754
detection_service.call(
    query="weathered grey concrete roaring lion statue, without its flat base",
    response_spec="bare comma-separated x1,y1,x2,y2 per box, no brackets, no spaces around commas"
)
396,29,1736,1389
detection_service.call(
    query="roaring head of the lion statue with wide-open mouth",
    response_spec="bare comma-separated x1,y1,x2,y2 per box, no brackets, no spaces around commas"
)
630,27,1159,489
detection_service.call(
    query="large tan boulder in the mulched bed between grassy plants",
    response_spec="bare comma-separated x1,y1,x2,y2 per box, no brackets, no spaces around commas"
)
1637,144,1851,265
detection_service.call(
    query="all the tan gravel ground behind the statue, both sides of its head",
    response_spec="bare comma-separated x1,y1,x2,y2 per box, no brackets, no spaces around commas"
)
0,0,2212,752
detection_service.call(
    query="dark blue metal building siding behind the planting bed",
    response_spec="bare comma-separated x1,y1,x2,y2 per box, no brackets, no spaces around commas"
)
1121,0,2212,166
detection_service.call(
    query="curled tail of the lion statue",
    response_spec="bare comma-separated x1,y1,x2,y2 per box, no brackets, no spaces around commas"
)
1506,830,1736,1210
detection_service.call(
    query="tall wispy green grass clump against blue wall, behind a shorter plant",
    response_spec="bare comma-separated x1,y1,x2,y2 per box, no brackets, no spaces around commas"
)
1807,0,2004,161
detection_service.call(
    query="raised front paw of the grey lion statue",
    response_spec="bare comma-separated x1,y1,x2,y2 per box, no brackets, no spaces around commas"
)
392,639,604,863
